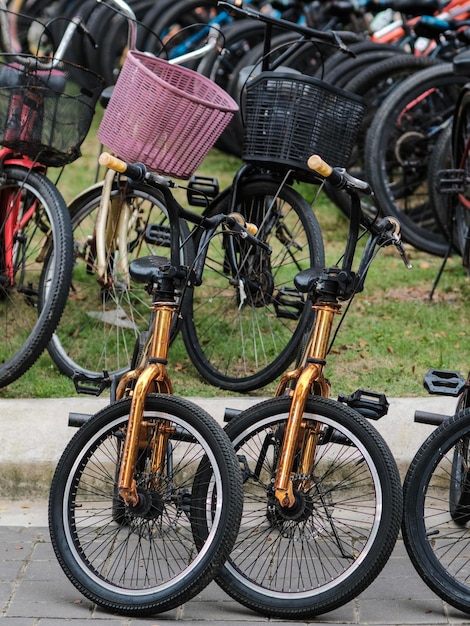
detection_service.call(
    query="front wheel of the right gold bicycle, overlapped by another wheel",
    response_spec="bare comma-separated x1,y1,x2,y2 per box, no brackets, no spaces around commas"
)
217,397,402,619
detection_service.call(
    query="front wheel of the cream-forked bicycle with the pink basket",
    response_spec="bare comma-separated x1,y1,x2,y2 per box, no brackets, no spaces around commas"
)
48,177,192,378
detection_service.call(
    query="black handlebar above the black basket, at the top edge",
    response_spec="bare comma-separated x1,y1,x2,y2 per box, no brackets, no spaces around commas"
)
217,0,363,47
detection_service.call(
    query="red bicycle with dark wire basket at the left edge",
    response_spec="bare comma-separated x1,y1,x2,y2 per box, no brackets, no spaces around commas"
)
0,2,102,387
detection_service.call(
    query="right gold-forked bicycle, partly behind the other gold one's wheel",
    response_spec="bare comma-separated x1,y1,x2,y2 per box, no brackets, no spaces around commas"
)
200,156,410,619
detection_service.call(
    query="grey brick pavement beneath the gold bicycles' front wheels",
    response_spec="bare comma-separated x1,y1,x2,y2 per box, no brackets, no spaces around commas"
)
0,510,470,626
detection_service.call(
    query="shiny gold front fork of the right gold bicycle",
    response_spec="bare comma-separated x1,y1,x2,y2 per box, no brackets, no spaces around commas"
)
274,302,341,507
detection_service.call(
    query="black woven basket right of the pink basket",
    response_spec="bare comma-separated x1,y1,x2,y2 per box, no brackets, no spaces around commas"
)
243,72,366,179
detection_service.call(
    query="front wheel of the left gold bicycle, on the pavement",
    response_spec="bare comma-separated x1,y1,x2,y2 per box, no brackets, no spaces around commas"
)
49,395,242,616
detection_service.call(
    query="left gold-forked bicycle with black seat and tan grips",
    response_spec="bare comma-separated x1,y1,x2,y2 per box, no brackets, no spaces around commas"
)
49,154,274,615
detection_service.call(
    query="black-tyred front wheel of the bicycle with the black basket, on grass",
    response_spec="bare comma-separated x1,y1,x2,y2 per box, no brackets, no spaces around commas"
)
182,178,325,391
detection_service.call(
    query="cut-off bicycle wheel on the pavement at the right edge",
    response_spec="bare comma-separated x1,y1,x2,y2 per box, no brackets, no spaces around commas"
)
403,409,470,613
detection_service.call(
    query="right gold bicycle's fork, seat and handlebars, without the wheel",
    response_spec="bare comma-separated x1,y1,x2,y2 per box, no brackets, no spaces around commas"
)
268,157,411,508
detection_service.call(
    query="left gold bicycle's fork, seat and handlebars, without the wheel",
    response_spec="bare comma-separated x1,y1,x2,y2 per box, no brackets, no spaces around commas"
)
100,153,267,507
